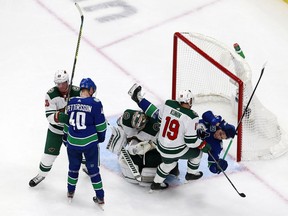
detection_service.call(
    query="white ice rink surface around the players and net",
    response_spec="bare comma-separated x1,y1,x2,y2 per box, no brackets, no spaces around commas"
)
0,0,288,216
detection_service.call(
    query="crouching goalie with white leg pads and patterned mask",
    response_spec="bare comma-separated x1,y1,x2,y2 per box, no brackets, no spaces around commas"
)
107,109,179,186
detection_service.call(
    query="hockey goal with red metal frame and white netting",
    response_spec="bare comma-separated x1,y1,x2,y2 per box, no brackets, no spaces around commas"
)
172,32,288,161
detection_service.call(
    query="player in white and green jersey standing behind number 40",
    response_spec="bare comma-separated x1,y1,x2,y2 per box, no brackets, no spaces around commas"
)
29,70,80,187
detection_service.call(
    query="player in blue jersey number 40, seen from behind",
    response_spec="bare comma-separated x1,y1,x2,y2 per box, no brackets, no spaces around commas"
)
64,78,107,205
